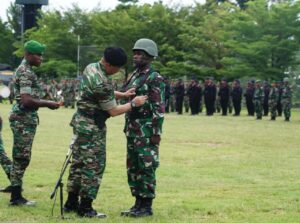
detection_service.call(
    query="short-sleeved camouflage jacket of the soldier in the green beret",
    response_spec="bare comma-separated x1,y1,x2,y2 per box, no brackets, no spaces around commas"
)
10,59,41,124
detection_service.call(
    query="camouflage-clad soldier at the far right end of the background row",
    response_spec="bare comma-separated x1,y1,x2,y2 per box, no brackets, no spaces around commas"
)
281,77,292,122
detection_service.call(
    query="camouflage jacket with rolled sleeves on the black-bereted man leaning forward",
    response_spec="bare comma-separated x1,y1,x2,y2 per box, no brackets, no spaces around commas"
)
70,63,117,134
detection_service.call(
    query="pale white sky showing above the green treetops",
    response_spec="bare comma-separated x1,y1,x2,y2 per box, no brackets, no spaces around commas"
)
0,0,204,21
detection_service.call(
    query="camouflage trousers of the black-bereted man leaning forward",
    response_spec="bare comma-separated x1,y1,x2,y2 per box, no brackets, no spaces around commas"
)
67,130,106,200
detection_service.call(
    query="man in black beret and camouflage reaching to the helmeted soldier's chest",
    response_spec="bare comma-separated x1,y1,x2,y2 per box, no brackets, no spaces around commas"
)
64,47,147,218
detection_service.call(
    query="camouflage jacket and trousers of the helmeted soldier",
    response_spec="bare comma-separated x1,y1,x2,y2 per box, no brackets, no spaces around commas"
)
124,67,165,198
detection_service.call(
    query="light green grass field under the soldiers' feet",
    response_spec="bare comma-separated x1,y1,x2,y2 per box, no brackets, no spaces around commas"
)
0,104,300,223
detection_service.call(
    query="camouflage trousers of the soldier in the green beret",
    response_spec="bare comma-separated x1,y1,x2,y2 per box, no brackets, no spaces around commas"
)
10,121,37,186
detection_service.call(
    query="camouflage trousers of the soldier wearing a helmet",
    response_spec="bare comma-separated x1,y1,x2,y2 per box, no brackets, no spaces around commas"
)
127,137,159,198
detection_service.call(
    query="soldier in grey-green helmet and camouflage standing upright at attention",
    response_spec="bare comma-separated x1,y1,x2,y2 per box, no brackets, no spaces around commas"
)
121,39,165,217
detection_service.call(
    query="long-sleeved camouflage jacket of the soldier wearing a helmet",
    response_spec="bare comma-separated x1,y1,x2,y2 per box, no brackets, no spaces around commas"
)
124,67,165,137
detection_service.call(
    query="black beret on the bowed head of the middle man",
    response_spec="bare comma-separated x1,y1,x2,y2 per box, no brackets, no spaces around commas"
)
104,47,127,67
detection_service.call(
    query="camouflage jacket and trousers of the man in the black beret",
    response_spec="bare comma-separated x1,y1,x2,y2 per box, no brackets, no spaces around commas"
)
68,63,117,200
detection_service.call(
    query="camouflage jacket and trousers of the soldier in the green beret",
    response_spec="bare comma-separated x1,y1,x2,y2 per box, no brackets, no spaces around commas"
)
9,59,41,186
